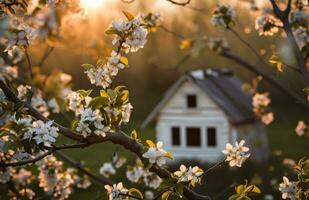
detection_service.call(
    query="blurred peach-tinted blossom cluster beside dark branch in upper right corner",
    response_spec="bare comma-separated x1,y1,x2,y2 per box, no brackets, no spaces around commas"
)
255,14,282,36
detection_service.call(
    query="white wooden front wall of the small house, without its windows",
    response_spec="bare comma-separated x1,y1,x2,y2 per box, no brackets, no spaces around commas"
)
156,81,231,162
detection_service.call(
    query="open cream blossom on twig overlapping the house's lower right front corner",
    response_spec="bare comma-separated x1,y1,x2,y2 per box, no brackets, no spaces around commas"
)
222,140,250,167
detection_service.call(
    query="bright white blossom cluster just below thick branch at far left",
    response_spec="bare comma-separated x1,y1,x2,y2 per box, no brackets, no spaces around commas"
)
23,120,59,146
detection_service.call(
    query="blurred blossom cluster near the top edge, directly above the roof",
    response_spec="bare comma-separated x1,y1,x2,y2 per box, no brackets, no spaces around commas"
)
211,5,235,30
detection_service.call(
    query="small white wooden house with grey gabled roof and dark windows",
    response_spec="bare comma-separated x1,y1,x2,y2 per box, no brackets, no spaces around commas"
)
142,69,268,163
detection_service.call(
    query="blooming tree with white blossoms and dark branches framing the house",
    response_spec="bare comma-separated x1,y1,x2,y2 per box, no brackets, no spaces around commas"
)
0,0,309,200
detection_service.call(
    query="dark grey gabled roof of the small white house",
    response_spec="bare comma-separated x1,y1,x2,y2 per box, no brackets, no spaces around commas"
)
142,68,254,127
